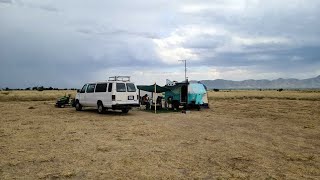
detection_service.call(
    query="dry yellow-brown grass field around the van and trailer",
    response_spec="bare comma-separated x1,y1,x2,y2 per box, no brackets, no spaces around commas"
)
0,91,320,180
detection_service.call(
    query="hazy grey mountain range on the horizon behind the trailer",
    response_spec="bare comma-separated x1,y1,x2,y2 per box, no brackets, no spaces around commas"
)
200,75,320,89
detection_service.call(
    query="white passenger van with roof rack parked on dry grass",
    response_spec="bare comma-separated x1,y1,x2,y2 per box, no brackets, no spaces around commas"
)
75,76,139,113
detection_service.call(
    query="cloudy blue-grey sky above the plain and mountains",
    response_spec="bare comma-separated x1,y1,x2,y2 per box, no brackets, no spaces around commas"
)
0,0,320,88
